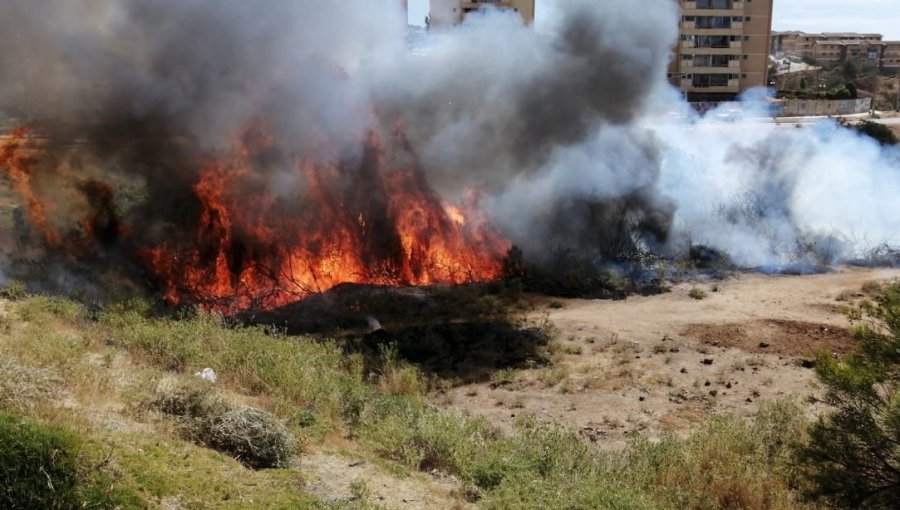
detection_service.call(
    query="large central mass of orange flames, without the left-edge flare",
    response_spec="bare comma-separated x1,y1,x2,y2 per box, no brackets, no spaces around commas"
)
142,126,507,312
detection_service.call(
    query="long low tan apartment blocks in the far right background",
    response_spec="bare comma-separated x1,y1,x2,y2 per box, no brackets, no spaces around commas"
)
769,31,900,74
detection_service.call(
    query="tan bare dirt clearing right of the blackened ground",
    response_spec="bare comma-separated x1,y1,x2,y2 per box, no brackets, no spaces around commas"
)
441,268,900,447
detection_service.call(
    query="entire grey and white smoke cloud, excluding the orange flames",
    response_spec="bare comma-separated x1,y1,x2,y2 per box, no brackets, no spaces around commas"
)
0,0,900,302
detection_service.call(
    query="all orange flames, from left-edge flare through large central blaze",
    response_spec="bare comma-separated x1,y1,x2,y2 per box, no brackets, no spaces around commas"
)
0,120,508,313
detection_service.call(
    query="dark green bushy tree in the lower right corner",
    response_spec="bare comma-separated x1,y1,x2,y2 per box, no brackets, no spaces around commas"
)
798,284,900,508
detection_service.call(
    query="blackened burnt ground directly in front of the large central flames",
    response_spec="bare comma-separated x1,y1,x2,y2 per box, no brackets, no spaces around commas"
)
236,283,549,382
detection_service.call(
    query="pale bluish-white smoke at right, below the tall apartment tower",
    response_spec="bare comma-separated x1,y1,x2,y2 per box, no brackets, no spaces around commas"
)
648,111,900,267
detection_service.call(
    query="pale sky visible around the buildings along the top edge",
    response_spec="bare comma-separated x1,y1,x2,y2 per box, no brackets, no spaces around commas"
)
409,0,900,41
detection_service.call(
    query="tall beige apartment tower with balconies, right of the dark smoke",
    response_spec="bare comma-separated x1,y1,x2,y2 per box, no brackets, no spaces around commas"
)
669,0,773,101
